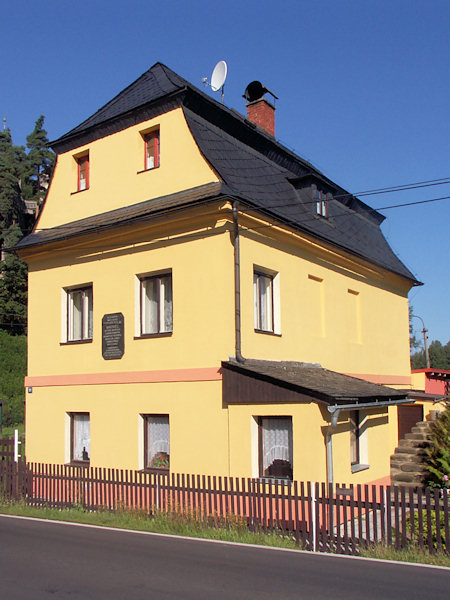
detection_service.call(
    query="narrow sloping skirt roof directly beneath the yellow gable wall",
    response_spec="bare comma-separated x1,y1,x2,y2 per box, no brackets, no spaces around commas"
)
15,183,229,250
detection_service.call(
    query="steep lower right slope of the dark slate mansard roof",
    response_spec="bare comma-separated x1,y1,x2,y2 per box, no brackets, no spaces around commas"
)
184,109,415,279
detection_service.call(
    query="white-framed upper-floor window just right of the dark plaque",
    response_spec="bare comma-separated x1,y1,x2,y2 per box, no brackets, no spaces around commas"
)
136,270,173,337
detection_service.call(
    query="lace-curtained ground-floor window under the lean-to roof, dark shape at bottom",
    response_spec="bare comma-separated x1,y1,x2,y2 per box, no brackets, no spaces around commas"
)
259,417,293,480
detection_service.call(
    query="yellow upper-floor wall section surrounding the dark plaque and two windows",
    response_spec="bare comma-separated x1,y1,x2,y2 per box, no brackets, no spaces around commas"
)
28,214,234,375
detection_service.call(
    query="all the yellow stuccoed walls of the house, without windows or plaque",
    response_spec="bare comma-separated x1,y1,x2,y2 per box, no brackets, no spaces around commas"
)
23,109,410,483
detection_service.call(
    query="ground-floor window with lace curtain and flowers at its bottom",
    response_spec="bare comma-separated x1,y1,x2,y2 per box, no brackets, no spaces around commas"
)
144,415,170,470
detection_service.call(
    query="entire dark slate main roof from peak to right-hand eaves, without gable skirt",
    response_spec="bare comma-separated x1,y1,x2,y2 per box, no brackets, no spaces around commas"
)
41,63,419,284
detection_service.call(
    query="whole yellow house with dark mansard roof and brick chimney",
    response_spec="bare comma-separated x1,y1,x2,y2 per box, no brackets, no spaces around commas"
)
17,63,418,483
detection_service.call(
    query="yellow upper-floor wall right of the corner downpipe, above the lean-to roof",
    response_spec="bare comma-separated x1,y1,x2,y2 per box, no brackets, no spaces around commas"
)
241,220,410,383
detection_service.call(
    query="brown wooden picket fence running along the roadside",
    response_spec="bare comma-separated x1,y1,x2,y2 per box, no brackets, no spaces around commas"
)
0,461,450,554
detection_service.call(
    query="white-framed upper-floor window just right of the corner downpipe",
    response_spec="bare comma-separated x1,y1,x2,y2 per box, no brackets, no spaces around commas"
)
253,265,281,335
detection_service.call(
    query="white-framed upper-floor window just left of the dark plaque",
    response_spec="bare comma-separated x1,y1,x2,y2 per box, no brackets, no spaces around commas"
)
61,283,94,343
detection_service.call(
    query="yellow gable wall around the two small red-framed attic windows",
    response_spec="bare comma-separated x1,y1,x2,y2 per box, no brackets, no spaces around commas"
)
38,108,218,228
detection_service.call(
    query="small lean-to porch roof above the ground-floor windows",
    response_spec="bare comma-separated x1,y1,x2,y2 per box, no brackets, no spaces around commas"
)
222,359,408,405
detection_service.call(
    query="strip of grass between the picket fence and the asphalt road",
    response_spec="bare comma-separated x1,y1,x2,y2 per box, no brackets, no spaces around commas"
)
0,500,450,568
